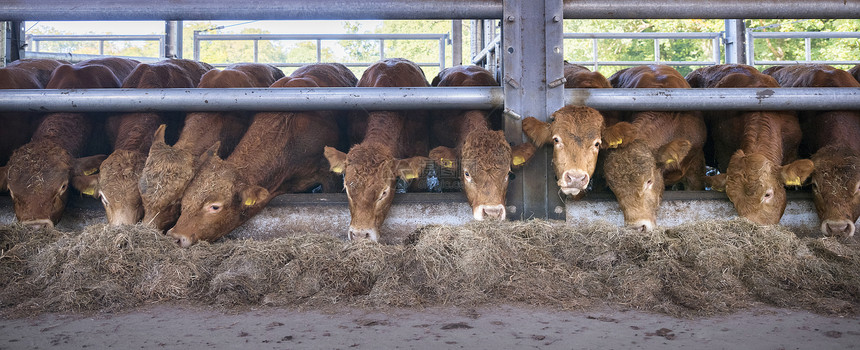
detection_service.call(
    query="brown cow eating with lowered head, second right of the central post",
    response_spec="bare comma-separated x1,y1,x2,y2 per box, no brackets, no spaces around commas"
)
603,65,707,232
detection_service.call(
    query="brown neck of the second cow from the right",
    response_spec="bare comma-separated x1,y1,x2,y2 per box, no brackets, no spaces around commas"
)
741,111,784,165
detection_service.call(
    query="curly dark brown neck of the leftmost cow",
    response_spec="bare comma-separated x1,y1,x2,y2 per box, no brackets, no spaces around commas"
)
32,113,93,157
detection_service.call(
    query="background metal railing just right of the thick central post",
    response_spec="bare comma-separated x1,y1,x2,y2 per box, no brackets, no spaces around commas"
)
564,32,723,71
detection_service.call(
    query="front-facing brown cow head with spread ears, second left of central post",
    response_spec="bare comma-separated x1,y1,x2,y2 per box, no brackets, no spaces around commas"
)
324,143,428,241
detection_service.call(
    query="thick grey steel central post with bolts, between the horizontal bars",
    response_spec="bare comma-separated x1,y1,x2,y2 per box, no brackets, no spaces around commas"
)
501,0,565,219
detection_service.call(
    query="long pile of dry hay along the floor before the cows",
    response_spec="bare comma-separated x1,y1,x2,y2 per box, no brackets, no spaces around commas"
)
0,219,860,316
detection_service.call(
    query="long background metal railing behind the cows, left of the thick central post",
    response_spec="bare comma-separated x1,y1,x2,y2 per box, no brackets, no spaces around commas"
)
193,32,449,70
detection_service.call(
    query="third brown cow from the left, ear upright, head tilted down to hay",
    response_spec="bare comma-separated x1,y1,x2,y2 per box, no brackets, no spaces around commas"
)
138,63,284,230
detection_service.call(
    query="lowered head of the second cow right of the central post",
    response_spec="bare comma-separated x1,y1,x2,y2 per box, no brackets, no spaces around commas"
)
603,139,691,232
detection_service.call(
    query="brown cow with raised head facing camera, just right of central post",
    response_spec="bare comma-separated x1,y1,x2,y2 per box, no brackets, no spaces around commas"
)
523,63,630,199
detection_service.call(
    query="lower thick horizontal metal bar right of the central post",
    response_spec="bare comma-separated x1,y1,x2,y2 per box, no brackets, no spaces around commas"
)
565,88,860,111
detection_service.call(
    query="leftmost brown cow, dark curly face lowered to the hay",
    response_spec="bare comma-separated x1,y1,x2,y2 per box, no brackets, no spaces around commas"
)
2,58,138,226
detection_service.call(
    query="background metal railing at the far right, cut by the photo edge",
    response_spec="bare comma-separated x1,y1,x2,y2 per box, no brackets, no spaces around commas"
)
746,29,860,66
